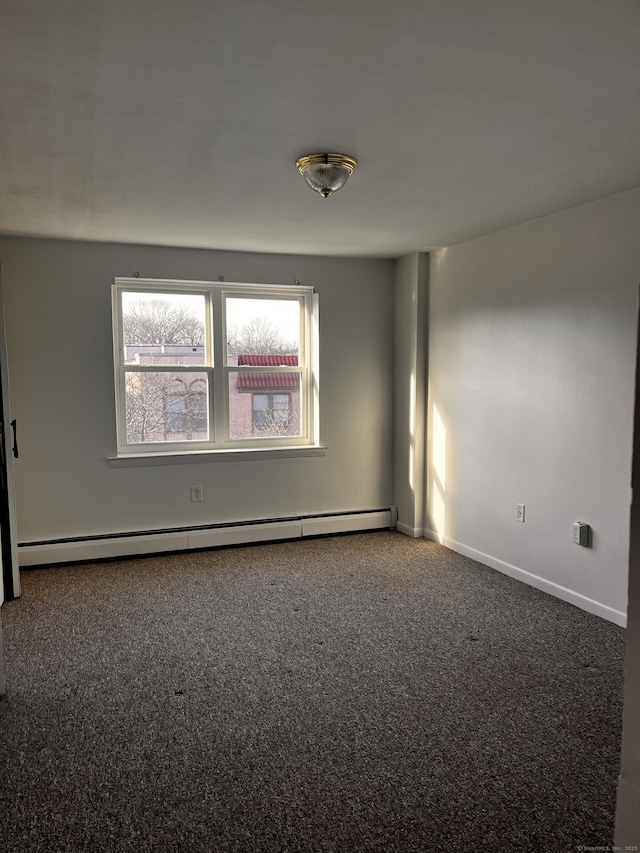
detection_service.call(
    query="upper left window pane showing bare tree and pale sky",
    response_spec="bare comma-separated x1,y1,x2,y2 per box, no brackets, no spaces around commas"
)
122,291,205,365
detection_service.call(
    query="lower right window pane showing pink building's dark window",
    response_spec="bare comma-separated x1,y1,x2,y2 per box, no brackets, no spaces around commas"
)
229,371,302,440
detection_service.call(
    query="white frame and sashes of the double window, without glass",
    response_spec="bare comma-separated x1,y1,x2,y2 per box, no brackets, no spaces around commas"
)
112,278,319,458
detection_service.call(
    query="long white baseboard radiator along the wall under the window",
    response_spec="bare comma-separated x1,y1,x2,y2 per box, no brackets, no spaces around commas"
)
18,506,398,566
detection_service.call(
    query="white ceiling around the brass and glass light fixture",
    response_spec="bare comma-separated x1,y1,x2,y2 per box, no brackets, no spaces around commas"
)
0,0,640,257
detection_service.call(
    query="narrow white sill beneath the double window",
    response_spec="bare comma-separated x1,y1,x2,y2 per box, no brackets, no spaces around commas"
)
107,444,328,468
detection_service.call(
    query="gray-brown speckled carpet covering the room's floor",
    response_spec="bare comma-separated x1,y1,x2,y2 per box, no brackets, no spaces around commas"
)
0,532,624,853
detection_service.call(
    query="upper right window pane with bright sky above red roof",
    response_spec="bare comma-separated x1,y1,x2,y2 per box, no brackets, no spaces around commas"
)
226,298,300,366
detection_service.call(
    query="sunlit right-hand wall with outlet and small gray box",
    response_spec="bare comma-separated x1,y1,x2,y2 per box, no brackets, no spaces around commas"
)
425,190,640,622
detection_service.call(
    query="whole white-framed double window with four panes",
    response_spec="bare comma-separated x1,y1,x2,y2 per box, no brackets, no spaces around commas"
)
113,278,317,455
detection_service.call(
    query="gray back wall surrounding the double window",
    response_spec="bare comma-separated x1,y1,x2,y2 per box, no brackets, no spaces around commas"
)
0,238,394,542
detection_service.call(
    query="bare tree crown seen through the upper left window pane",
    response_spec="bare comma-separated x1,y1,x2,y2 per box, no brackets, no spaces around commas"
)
122,296,204,346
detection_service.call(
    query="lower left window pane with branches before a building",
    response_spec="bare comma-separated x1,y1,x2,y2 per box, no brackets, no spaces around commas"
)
126,372,209,444
